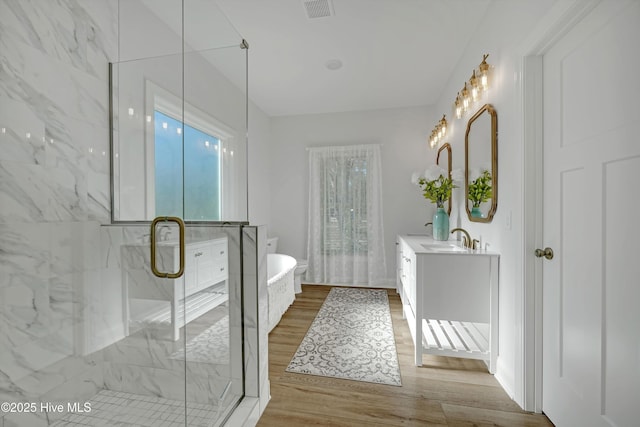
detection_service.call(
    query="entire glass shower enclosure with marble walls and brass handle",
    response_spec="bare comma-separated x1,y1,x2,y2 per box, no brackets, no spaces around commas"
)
0,0,260,427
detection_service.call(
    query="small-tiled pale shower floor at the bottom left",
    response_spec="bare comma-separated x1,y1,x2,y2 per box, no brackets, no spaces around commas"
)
51,390,217,427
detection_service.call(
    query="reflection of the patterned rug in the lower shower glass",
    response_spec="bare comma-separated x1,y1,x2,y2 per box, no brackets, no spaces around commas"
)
169,316,229,365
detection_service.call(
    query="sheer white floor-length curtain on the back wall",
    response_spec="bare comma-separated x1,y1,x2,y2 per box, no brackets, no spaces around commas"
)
307,145,387,286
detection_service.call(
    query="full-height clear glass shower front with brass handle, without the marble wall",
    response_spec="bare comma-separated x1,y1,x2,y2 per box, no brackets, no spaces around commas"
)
107,0,247,426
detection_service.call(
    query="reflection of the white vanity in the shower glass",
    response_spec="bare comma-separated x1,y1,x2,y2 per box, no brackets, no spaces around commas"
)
122,237,229,340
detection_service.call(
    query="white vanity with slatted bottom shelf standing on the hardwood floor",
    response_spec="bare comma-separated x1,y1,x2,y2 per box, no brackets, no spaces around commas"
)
396,235,500,374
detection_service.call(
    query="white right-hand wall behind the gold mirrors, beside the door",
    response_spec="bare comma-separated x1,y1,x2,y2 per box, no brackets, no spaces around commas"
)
436,1,554,405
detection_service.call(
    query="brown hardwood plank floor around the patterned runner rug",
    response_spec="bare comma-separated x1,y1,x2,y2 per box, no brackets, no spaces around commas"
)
258,285,553,427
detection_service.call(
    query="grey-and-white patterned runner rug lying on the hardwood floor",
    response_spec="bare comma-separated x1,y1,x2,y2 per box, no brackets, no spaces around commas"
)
286,288,402,386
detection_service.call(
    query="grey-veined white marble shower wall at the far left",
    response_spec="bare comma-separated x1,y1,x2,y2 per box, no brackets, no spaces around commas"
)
0,0,117,426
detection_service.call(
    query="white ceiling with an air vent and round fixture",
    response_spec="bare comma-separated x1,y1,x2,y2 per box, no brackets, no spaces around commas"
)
217,0,490,116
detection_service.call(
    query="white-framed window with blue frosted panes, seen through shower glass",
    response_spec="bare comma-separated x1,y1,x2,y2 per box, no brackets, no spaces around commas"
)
146,81,235,221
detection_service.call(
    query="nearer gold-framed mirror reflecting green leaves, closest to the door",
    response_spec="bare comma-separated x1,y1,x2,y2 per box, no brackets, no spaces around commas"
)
464,104,498,222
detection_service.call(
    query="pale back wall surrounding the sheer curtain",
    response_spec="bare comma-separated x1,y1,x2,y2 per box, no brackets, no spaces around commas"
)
268,107,436,286
